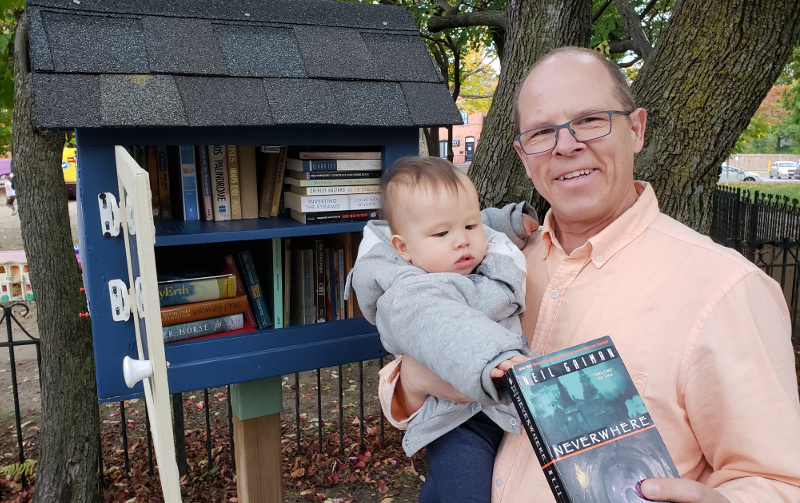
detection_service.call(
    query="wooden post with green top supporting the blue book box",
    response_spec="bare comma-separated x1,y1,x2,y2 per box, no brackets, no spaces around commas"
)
231,376,283,503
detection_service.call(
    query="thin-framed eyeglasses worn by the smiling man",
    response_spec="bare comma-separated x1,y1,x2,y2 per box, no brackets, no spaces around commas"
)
514,110,631,155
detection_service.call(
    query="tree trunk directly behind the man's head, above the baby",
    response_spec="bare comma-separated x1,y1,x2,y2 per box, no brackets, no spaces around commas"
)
469,0,592,214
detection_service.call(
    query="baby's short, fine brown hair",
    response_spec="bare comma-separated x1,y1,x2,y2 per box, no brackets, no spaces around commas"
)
381,156,469,234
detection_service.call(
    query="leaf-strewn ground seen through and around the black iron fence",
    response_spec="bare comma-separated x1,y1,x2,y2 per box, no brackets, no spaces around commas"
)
0,201,427,503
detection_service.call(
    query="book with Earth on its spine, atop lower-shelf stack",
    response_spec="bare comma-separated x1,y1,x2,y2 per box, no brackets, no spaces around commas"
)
158,272,236,307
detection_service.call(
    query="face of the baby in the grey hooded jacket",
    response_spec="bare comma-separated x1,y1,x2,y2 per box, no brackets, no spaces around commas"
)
392,180,486,275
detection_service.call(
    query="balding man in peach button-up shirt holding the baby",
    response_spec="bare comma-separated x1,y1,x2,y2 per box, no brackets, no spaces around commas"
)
381,48,800,503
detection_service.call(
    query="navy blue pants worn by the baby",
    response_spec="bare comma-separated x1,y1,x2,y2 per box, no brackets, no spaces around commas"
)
419,412,503,503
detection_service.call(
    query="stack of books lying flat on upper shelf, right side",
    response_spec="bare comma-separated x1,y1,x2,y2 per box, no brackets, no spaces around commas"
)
283,151,382,224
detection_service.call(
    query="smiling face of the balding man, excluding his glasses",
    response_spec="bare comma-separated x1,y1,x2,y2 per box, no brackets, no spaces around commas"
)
514,55,646,232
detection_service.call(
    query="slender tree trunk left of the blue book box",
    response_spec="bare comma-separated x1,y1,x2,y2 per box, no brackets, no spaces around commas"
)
13,14,100,503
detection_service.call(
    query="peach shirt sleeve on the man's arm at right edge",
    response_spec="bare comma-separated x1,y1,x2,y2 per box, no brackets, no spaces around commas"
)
685,272,800,503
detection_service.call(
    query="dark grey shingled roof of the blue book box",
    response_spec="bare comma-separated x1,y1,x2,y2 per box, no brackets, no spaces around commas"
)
26,0,461,132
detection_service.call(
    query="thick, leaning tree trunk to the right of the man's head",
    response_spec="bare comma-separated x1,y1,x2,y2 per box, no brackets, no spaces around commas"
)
633,0,800,233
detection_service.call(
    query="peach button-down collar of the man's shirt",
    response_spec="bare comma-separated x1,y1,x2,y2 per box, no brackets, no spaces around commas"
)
542,181,660,268
